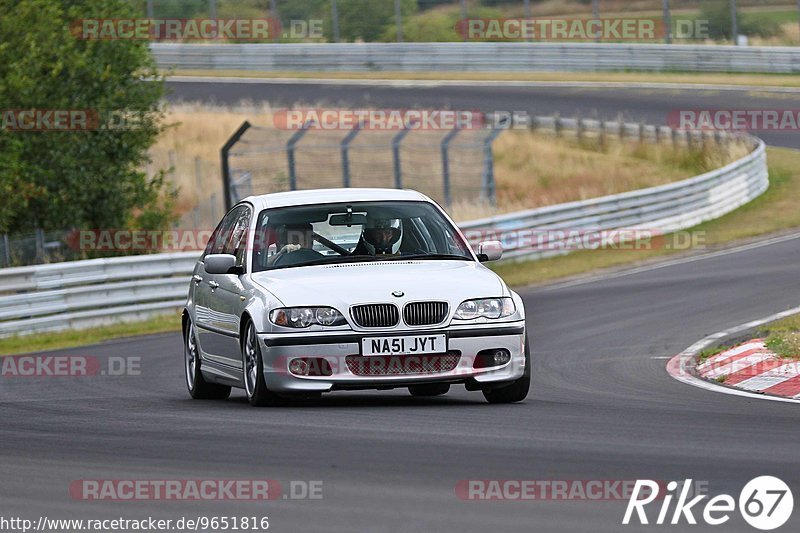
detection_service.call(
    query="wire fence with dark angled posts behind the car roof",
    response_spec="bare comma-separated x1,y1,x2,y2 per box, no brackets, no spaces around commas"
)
223,120,501,207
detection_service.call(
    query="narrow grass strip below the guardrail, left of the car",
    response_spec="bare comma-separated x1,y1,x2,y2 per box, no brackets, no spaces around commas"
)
0,313,181,357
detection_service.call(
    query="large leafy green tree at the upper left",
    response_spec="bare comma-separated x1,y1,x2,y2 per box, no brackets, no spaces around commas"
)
0,0,174,232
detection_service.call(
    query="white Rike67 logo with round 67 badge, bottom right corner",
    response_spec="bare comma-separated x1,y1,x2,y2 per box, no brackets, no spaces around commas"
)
622,476,794,531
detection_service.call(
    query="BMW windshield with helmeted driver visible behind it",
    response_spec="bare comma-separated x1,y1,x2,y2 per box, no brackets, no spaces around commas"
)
253,201,474,272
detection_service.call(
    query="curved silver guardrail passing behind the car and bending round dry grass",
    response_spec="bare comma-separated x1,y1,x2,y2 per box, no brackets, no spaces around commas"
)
0,123,769,337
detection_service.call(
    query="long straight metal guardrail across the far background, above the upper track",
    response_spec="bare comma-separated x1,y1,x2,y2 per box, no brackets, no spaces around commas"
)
150,43,800,74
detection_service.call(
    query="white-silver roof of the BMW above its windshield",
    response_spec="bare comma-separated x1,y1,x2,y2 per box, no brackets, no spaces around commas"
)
242,188,432,210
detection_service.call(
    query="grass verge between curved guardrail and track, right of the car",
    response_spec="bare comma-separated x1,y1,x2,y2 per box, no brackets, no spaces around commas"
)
492,148,800,287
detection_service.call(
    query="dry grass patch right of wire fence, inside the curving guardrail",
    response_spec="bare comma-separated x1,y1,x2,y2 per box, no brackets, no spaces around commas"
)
452,131,748,221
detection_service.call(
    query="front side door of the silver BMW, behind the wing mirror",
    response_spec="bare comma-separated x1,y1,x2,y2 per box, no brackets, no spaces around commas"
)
206,204,252,369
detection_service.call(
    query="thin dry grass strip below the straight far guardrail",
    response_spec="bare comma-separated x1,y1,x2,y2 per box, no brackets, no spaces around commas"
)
169,70,800,87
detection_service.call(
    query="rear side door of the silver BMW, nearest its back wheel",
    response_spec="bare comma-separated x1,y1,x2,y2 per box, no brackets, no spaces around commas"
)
192,207,240,363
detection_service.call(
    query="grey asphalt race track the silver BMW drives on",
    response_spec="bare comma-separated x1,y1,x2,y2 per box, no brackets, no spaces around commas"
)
0,80,800,533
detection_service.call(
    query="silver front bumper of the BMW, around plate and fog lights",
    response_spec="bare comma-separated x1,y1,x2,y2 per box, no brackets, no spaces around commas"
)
258,321,525,393
